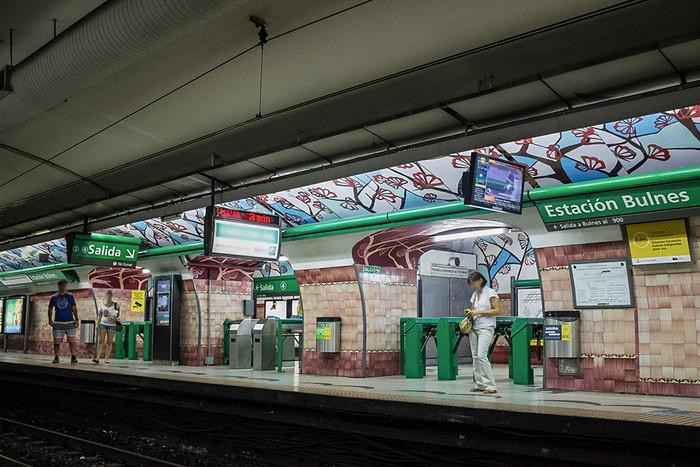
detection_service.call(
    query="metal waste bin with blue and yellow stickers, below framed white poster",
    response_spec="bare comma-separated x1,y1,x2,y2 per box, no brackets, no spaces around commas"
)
542,310,581,358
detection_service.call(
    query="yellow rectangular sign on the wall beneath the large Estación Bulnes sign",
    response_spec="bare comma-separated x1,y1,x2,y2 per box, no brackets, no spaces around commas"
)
626,219,691,266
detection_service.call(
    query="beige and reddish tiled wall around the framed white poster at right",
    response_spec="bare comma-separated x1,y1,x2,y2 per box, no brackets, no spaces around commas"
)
536,232,700,395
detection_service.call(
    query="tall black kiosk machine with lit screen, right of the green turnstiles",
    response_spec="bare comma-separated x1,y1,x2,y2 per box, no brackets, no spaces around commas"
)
152,275,182,362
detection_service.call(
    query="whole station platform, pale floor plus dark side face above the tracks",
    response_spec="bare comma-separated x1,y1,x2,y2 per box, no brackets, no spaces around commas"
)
0,353,700,465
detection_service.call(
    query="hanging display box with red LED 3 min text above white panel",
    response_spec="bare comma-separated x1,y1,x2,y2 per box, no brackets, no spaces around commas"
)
204,207,282,261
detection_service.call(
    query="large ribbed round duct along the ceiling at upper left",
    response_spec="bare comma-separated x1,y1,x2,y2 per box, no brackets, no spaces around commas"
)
0,0,248,130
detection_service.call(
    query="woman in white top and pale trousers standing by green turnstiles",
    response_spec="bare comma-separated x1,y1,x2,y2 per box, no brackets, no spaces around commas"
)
465,272,500,394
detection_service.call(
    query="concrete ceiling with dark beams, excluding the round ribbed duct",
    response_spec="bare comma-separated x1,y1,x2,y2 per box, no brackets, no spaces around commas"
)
0,0,700,248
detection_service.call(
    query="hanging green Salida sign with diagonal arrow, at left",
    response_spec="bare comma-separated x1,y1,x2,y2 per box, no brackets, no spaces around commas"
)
66,233,141,268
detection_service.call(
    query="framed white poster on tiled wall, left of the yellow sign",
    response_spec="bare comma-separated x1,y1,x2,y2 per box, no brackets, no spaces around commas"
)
569,258,634,308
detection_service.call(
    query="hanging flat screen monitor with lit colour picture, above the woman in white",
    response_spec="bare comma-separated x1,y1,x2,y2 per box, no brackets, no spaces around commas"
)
462,152,525,214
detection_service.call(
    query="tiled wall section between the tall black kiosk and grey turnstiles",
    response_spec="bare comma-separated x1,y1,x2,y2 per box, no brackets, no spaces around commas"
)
180,279,252,365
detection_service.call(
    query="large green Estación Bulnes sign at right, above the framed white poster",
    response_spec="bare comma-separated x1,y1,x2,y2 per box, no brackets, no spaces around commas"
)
536,180,700,232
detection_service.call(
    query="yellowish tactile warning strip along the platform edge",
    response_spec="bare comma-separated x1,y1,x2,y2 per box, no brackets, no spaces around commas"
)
0,354,700,427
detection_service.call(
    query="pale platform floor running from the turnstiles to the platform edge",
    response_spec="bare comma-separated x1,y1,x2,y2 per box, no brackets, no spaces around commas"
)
0,353,700,427
